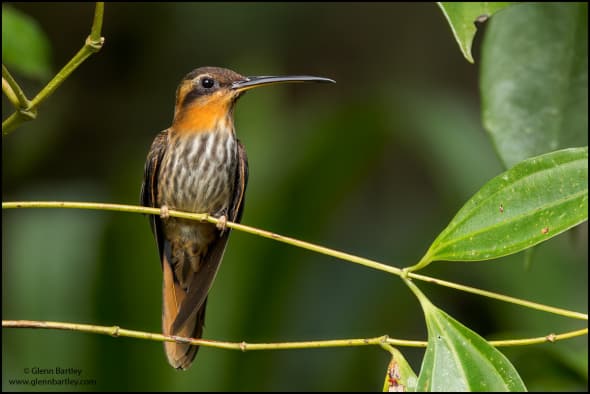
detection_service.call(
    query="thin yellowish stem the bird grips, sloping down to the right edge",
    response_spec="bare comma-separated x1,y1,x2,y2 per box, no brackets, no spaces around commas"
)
2,201,588,320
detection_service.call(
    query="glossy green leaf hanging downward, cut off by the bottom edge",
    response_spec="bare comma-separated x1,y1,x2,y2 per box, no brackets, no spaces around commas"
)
406,281,526,391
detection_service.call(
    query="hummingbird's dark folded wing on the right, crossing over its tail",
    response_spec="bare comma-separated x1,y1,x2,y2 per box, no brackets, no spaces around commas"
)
172,141,248,332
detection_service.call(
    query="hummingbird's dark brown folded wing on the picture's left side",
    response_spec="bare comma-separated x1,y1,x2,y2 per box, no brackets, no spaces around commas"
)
141,130,168,262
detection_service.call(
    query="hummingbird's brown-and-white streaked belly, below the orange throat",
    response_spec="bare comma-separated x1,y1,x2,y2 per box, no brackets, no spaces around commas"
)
158,132,237,215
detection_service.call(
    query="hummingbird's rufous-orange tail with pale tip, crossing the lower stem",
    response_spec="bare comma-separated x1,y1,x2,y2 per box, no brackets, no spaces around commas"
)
162,258,207,370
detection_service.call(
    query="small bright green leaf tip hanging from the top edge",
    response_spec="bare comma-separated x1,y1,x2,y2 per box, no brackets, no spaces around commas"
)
438,2,510,63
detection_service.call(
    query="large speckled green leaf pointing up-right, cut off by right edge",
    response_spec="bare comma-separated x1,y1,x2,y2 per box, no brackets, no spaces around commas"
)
409,147,588,271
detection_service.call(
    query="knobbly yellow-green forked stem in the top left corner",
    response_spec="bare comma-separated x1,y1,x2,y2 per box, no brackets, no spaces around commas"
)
2,2,104,135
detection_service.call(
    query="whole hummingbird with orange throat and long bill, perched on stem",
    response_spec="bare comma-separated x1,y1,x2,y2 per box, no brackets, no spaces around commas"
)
141,67,335,370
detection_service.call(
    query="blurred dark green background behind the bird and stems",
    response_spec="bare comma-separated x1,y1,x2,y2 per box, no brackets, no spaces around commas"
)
2,3,588,391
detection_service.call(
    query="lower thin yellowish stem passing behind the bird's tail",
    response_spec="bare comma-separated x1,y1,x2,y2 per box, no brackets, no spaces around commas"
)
2,320,588,354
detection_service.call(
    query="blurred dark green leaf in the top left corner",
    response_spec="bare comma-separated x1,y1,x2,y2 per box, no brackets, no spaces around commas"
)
2,5,51,80
